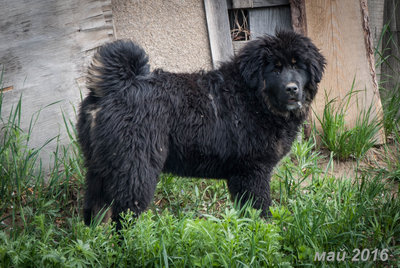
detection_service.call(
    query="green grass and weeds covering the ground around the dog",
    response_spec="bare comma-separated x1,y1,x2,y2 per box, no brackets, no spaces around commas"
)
0,26,400,267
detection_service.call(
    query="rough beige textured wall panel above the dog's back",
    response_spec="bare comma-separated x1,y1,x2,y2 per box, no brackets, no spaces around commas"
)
112,0,212,72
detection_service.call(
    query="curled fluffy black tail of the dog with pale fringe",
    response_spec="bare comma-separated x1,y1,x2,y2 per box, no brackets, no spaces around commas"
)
87,40,150,97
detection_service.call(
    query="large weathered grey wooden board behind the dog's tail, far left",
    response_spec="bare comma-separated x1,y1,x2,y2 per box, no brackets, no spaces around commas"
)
0,0,113,165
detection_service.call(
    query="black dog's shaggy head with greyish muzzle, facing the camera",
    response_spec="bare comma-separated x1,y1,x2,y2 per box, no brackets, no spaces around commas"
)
239,31,326,115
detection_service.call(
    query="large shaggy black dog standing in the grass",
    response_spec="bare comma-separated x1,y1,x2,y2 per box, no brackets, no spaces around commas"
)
77,32,325,224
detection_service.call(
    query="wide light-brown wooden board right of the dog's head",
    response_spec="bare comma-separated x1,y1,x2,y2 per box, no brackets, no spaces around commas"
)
305,0,383,141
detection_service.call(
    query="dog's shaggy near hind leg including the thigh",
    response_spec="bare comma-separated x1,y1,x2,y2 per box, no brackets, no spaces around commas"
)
85,90,169,228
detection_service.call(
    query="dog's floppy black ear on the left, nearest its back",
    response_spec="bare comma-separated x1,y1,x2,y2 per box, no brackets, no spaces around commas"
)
238,39,269,88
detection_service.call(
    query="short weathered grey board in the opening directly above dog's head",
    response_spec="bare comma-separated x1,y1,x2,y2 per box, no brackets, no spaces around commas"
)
249,5,292,39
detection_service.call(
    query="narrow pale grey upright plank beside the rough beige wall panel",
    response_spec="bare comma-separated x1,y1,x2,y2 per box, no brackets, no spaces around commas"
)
204,0,233,68
